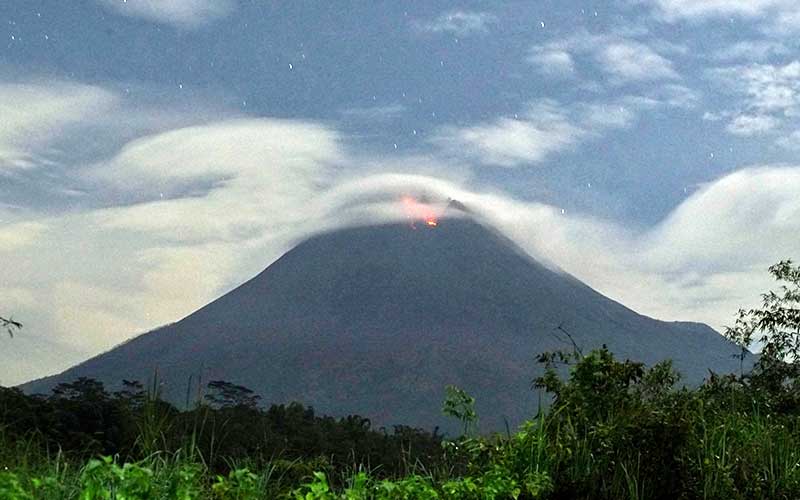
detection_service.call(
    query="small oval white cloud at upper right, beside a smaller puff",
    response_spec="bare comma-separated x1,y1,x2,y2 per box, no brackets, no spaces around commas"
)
597,41,678,81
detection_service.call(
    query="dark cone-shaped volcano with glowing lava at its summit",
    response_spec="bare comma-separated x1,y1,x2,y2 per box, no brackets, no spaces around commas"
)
24,210,752,430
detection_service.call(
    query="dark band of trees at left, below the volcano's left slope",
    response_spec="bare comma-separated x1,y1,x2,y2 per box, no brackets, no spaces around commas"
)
0,377,443,474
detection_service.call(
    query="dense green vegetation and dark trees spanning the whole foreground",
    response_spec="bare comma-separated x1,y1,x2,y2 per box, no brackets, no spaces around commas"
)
0,261,800,500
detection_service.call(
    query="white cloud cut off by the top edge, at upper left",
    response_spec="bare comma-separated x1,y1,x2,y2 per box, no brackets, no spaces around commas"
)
97,0,236,28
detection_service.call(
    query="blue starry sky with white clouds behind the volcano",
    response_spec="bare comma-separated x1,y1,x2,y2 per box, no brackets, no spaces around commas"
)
0,0,800,385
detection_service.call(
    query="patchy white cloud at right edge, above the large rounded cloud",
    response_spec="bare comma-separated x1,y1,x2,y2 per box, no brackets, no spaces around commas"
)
709,61,800,135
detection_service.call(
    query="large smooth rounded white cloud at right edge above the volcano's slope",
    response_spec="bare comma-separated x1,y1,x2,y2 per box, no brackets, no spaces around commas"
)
648,167,800,274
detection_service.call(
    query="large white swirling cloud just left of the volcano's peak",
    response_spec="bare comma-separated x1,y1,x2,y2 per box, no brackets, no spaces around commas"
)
94,119,342,242
